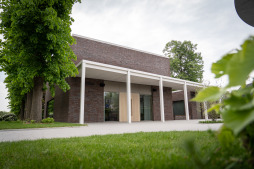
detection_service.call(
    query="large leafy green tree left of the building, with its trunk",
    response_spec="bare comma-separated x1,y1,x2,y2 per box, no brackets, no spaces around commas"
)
0,0,80,121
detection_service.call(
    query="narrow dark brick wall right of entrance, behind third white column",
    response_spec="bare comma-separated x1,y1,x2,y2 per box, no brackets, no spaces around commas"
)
152,86,174,121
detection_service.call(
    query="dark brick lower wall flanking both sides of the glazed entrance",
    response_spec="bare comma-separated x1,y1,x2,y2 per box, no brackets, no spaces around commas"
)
47,77,174,123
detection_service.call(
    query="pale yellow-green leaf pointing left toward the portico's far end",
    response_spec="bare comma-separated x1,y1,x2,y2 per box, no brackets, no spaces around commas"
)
192,86,226,102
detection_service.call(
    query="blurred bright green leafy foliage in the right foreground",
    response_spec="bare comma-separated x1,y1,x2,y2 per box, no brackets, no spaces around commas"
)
193,36,254,165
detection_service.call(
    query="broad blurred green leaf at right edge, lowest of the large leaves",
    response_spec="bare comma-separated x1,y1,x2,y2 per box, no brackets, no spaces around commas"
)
222,109,254,135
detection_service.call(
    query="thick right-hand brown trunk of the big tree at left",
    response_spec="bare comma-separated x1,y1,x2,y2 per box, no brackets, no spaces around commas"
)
31,77,43,122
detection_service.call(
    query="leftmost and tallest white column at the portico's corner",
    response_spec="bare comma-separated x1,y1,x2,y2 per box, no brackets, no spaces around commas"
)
79,61,86,124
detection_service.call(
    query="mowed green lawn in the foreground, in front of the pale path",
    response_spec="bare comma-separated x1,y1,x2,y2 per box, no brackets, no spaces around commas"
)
0,131,216,169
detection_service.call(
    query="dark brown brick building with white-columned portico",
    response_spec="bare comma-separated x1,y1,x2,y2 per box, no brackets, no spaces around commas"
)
45,35,202,123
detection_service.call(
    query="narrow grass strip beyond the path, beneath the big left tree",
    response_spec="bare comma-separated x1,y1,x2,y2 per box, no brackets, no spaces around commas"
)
0,121,84,130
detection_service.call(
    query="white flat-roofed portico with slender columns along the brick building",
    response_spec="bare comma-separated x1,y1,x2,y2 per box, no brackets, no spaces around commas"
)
76,60,205,124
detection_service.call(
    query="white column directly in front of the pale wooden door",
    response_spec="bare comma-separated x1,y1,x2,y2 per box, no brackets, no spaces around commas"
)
126,70,131,123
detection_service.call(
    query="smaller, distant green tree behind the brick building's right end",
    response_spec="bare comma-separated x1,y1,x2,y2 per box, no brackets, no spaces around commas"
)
163,40,204,82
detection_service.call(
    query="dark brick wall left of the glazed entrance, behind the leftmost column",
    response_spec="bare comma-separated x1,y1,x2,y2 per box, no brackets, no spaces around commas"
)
54,77,104,123
